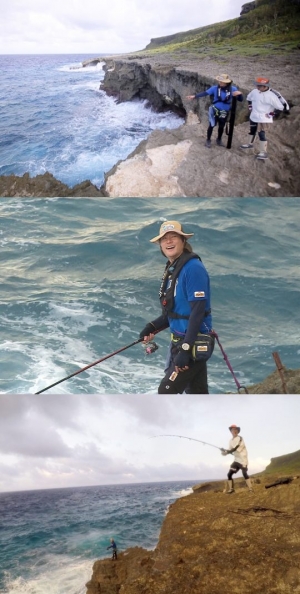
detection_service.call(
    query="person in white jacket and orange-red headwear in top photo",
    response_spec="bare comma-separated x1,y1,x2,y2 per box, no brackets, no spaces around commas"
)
241,77,290,159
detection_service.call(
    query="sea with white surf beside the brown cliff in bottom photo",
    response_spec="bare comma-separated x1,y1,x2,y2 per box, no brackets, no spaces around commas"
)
0,481,195,594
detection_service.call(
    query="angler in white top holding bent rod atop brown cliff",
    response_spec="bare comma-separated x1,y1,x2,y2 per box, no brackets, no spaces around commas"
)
221,425,253,494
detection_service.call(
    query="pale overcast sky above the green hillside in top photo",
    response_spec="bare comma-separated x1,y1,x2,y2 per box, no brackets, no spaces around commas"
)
0,0,245,55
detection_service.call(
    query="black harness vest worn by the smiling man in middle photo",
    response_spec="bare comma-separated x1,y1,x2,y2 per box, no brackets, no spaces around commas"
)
159,252,211,320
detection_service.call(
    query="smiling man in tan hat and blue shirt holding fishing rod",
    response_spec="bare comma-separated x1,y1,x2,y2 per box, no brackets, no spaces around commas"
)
140,221,214,394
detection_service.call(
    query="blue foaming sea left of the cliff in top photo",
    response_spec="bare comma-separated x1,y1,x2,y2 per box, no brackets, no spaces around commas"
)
0,55,183,187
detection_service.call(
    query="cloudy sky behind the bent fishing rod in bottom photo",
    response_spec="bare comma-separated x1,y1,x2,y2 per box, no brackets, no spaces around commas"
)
0,394,300,492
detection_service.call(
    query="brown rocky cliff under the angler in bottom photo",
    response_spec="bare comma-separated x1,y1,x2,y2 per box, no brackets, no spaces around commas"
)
87,474,300,594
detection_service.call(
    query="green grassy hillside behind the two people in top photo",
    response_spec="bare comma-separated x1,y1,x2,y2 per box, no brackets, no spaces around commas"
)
143,0,300,57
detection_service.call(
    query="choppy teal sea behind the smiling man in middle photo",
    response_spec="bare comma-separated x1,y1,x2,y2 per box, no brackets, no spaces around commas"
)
0,198,300,397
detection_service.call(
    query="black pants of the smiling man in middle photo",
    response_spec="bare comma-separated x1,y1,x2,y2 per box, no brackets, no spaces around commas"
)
158,347,208,394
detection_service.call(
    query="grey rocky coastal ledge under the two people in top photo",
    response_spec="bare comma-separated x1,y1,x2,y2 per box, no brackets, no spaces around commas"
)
0,51,300,198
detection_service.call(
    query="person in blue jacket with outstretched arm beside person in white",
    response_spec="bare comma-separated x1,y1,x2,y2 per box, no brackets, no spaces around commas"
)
187,74,243,148
